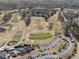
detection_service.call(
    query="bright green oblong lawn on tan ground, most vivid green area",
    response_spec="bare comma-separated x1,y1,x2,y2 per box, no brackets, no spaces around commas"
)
29,33,52,40
